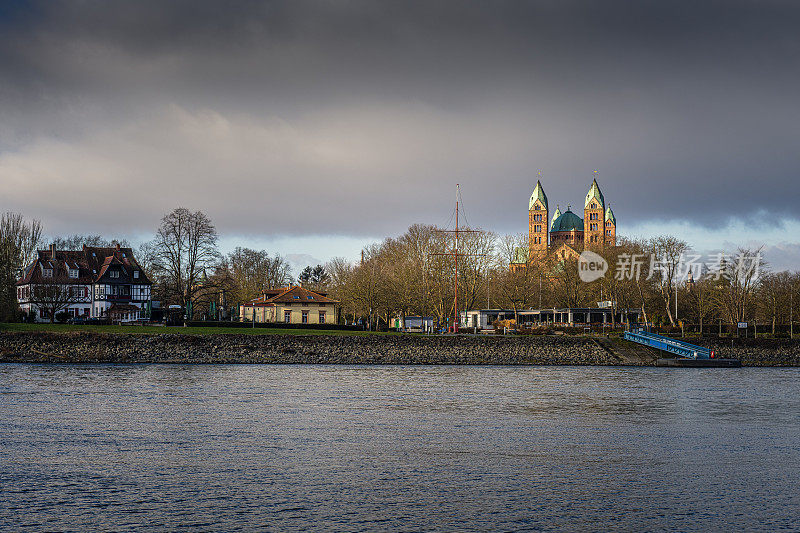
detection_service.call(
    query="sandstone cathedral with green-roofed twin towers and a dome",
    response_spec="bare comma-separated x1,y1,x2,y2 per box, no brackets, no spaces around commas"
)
528,175,617,258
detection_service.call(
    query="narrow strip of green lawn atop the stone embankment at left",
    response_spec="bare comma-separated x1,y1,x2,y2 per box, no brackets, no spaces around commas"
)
0,323,400,335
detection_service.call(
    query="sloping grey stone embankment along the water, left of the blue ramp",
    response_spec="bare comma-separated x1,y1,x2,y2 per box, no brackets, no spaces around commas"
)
0,332,623,365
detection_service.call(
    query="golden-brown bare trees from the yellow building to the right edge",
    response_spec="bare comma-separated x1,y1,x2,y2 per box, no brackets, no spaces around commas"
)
325,221,800,332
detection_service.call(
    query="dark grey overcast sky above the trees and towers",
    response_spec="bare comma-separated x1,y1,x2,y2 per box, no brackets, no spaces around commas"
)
0,0,800,269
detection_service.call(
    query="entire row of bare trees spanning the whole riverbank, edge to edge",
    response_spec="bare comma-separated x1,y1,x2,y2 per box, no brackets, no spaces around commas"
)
0,208,800,331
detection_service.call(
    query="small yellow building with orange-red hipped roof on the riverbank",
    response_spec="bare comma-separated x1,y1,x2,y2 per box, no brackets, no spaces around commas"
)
239,286,339,324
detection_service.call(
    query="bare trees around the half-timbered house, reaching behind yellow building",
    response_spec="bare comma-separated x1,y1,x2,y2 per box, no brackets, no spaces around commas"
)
0,208,300,322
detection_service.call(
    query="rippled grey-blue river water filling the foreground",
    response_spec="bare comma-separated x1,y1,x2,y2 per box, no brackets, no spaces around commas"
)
0,365,800,531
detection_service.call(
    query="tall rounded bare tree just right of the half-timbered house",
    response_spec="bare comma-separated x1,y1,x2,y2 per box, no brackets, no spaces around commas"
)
152,207,219,309
